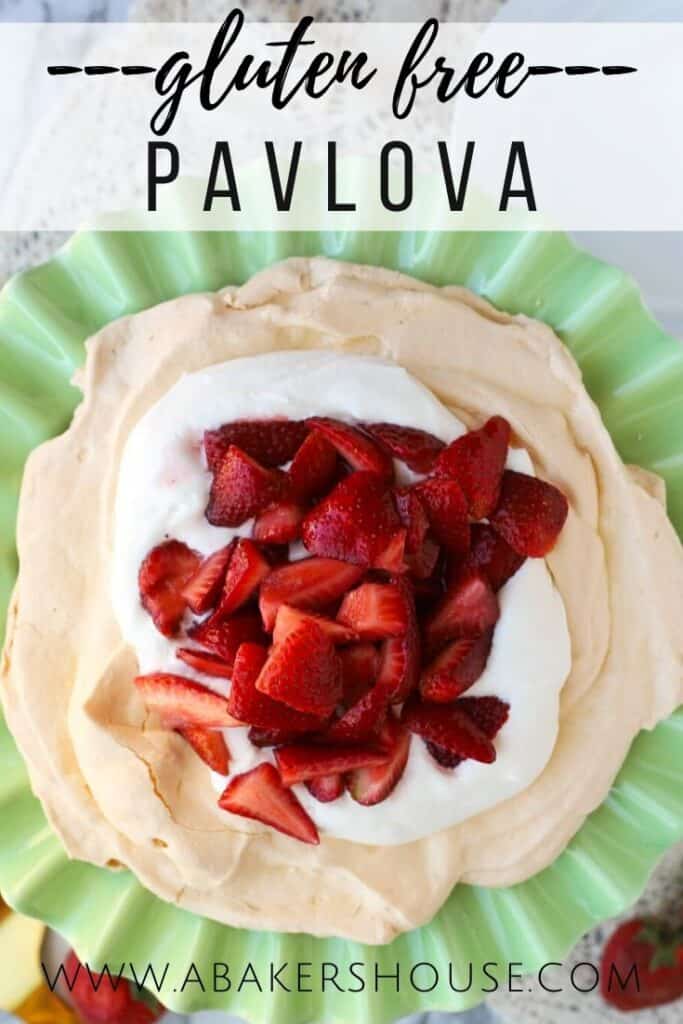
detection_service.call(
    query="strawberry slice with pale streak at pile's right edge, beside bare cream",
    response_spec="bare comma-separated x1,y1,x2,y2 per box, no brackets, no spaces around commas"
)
424,571,500,657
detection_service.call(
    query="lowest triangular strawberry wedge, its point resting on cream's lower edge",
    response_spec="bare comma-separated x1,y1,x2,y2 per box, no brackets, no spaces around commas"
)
218,762,319,846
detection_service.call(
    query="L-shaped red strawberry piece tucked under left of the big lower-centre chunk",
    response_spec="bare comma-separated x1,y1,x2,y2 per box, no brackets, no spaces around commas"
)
227,643,321,745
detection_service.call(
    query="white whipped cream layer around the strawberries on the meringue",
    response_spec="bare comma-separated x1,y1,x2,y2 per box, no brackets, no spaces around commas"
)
112,351,571,845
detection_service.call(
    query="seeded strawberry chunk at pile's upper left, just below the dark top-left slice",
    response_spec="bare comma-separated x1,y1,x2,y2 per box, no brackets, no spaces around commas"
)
206,444,287,526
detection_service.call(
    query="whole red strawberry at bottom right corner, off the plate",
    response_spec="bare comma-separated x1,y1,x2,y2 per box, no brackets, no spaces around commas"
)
600,918,683,1012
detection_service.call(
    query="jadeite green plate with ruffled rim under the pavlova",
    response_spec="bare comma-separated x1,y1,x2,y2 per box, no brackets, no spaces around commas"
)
0,232,683,1024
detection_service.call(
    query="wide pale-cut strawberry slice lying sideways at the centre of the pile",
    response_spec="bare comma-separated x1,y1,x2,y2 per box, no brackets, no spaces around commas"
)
259,558,364,631
